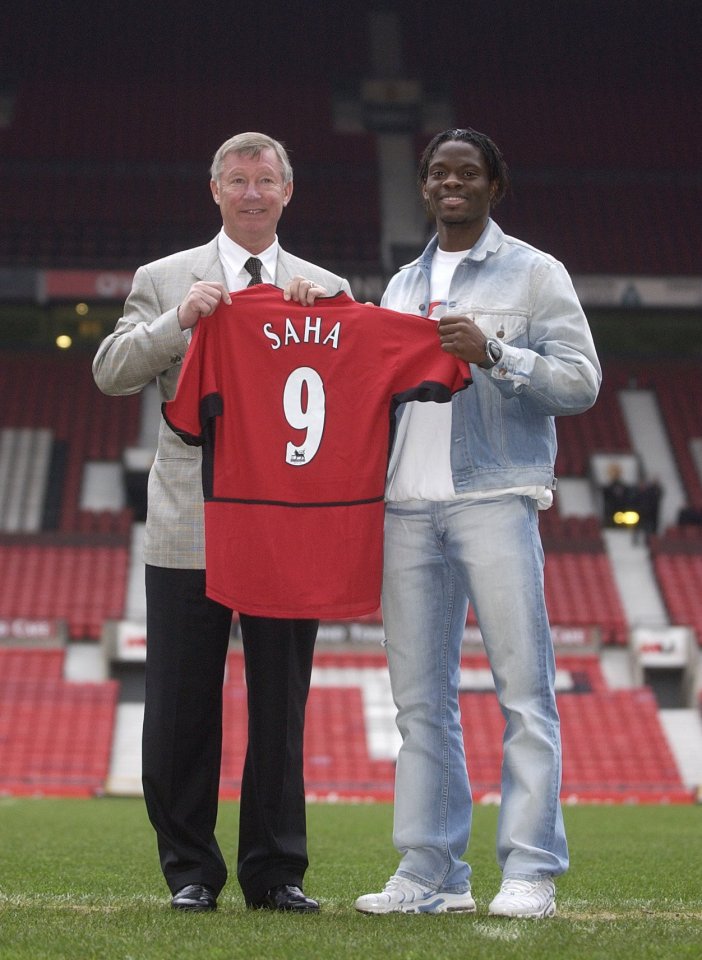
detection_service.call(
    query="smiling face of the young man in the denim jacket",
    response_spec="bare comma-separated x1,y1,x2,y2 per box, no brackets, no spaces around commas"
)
422,140,496,250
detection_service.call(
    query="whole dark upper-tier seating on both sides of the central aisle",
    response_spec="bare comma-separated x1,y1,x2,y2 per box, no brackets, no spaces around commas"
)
0,79,702,275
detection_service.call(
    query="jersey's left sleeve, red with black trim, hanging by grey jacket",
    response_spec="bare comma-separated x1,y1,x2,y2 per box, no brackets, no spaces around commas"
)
161,314,222,446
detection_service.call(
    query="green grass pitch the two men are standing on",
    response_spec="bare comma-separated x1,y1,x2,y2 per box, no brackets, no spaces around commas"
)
0,798,702,960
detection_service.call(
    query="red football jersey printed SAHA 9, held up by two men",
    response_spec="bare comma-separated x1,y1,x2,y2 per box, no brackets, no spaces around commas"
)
163,284,471,619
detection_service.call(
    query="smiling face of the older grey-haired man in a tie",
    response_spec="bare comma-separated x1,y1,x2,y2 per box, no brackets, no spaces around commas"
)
210,147,293,254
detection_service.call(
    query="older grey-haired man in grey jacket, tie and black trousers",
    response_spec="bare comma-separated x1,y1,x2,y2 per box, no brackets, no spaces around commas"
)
93,133,350,913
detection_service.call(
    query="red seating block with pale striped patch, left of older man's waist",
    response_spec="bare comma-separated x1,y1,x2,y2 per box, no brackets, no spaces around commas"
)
0,352,140,640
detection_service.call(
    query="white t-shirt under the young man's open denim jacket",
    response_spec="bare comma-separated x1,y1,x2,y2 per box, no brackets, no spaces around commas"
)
386,247,553,510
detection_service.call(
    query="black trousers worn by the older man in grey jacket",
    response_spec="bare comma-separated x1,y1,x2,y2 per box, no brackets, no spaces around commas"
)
142,566,318,902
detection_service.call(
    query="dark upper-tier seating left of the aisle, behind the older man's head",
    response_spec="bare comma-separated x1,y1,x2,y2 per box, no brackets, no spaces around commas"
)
0,79,379,269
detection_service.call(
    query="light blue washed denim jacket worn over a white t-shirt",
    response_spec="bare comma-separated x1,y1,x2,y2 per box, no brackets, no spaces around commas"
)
382,220,602,493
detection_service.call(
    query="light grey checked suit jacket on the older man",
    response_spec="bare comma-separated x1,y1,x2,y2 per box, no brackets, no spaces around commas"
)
93,237,351,569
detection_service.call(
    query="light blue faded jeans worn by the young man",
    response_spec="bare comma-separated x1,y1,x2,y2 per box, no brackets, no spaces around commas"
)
383,496,568,892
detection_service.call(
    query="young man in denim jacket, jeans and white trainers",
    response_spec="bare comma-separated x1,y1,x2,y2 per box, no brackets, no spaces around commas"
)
356,130,601,917
